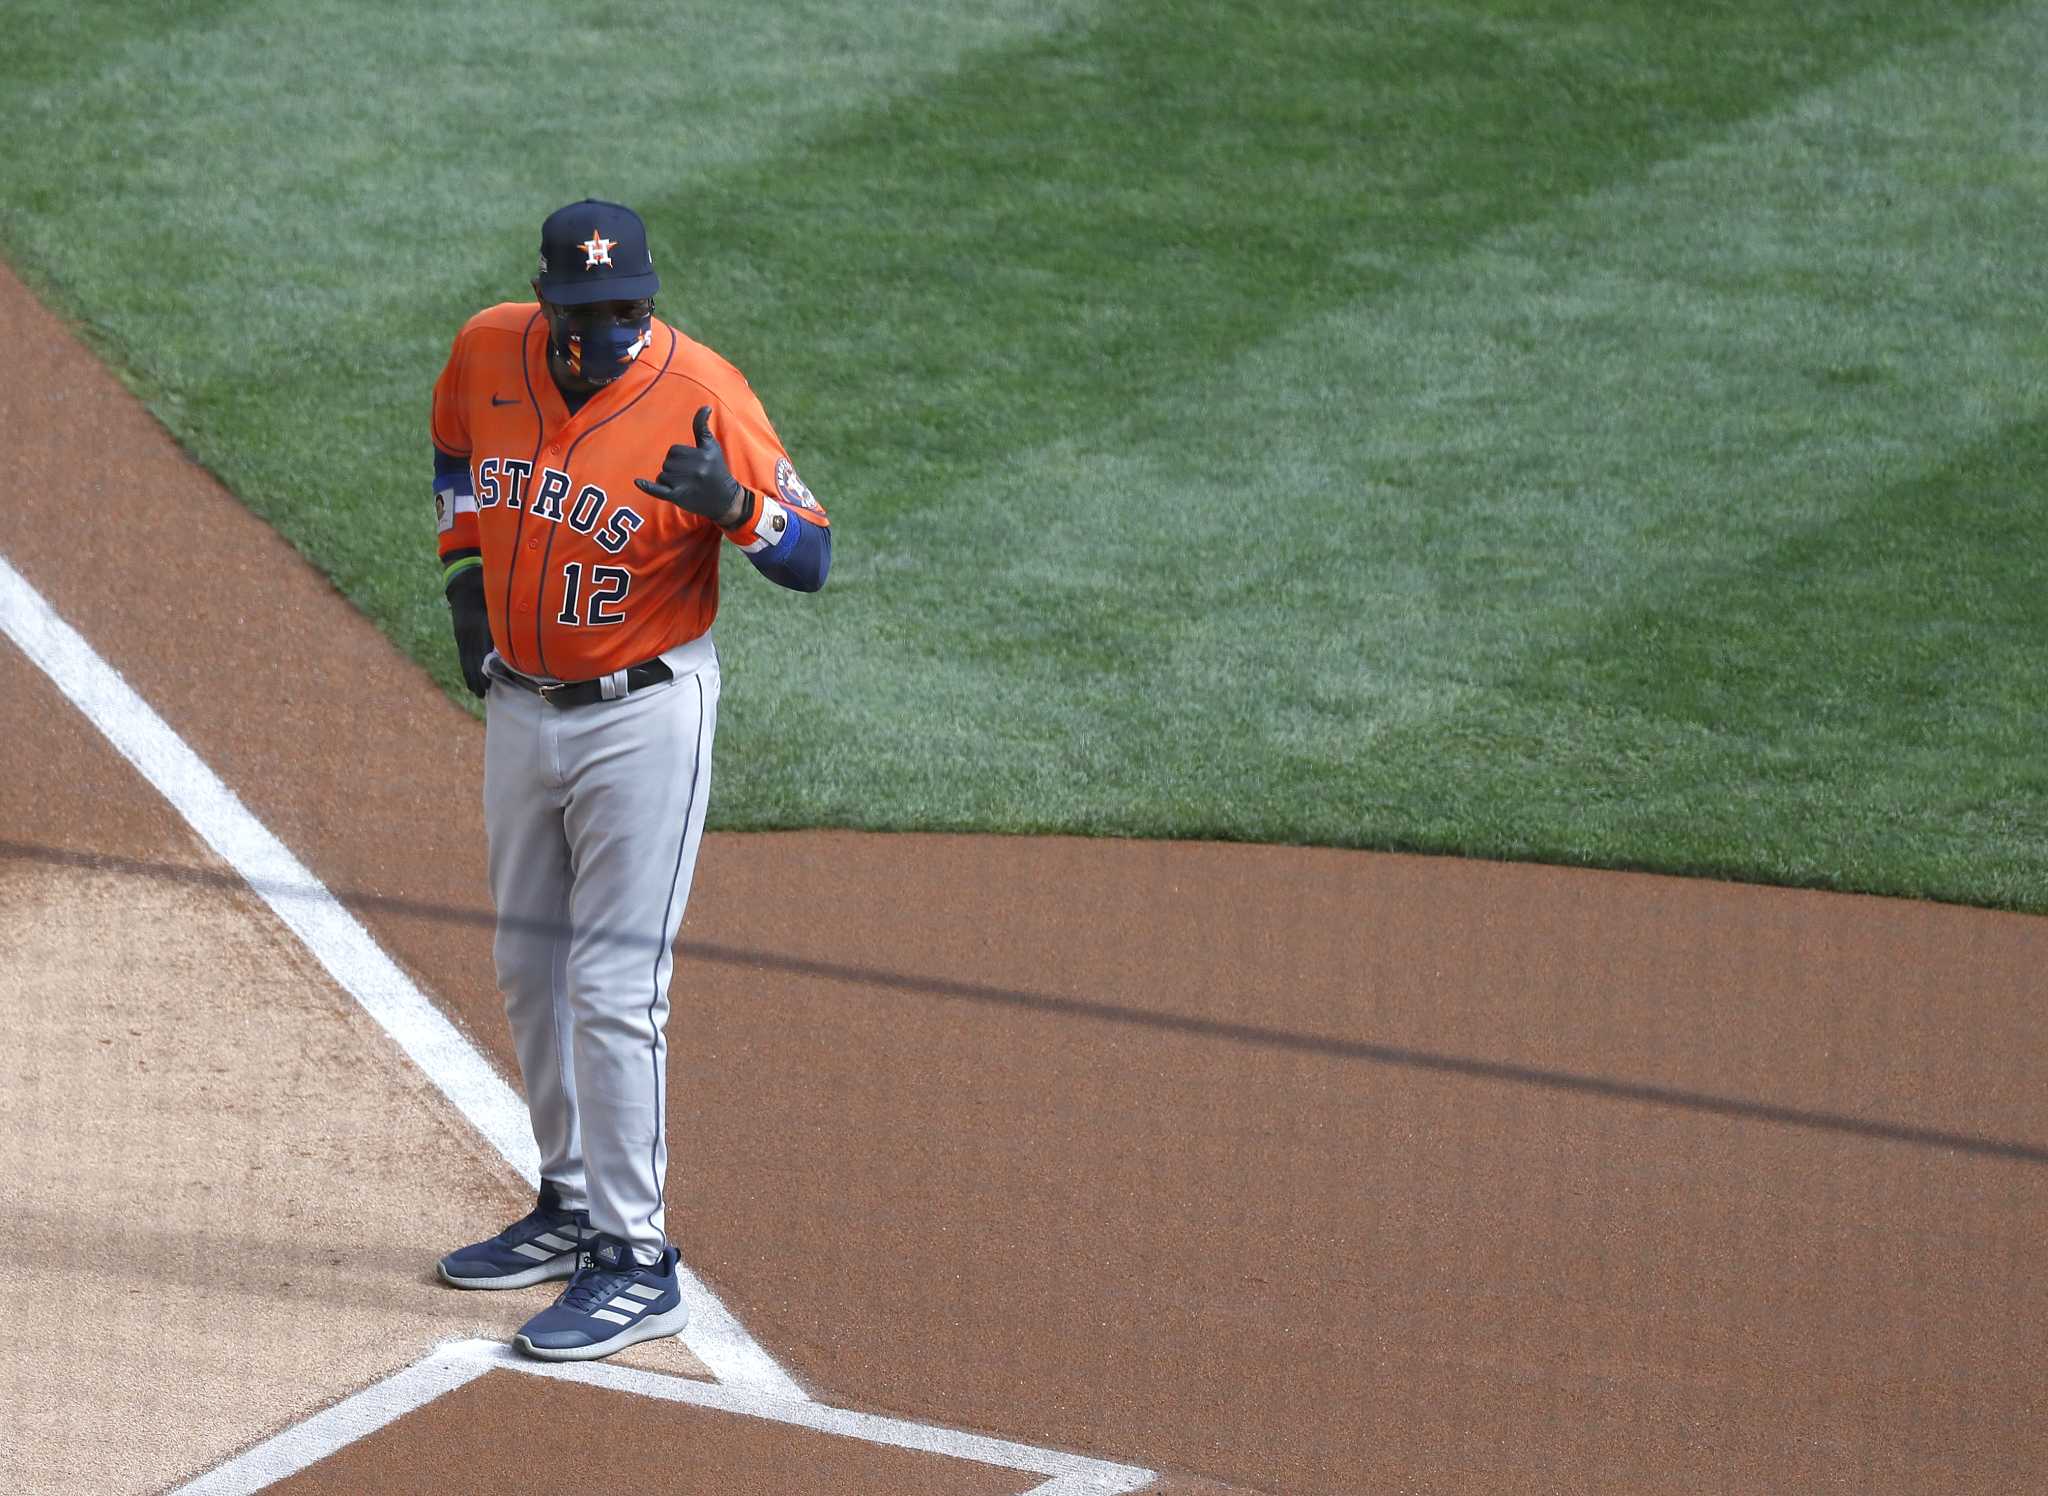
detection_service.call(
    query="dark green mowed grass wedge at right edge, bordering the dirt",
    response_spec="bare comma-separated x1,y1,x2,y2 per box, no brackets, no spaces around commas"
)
1499,414,2048,910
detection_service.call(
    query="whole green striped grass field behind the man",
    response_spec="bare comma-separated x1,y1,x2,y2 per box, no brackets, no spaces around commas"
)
0,0,2048,910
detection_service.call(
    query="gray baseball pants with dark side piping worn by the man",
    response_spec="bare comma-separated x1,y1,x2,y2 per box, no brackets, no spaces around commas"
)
483,635,719,1262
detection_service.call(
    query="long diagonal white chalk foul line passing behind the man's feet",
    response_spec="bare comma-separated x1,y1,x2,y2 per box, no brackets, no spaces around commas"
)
0,555,805,1398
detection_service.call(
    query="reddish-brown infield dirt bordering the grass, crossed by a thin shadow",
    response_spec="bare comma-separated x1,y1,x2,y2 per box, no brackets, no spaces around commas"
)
0,259,2048,1496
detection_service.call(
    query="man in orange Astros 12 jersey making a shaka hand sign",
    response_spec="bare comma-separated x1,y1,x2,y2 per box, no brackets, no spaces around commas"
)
432,199,831,1361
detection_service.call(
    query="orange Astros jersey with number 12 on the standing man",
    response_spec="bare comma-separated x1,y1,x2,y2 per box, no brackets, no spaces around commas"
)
432,301,829,680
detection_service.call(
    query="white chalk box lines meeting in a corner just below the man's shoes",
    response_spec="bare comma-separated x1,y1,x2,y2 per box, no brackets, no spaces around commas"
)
176,1340,1153,1496
